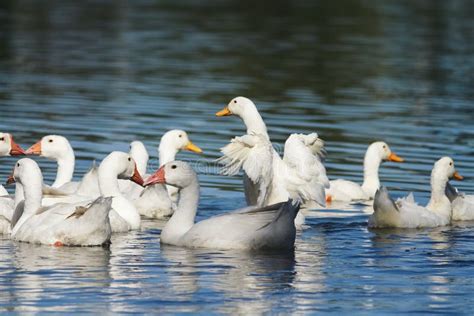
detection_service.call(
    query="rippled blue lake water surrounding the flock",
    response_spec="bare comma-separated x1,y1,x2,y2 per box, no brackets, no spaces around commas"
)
0,0,474,314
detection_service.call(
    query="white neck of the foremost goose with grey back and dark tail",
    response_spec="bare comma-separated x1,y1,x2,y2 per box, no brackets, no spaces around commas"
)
163,179,199,238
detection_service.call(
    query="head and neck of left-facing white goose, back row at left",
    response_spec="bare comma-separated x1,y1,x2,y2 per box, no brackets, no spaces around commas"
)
26,135,80,194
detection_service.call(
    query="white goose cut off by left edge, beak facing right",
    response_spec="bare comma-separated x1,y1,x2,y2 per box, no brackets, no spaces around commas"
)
0,132,25,235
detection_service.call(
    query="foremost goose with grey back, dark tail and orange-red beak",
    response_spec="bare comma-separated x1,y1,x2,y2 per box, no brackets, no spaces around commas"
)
145,161,299,250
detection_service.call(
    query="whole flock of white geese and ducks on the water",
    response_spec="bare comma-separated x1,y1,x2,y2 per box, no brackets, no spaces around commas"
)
0,97,474,250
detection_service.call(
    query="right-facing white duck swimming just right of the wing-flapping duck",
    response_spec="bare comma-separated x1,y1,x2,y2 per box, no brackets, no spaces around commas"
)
326,142,403,202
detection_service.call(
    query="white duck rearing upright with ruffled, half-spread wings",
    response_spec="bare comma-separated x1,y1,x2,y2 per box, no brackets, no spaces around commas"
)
216,97,329,226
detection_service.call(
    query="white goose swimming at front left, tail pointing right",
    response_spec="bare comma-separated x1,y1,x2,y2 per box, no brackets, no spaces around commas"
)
10,158,112,246
